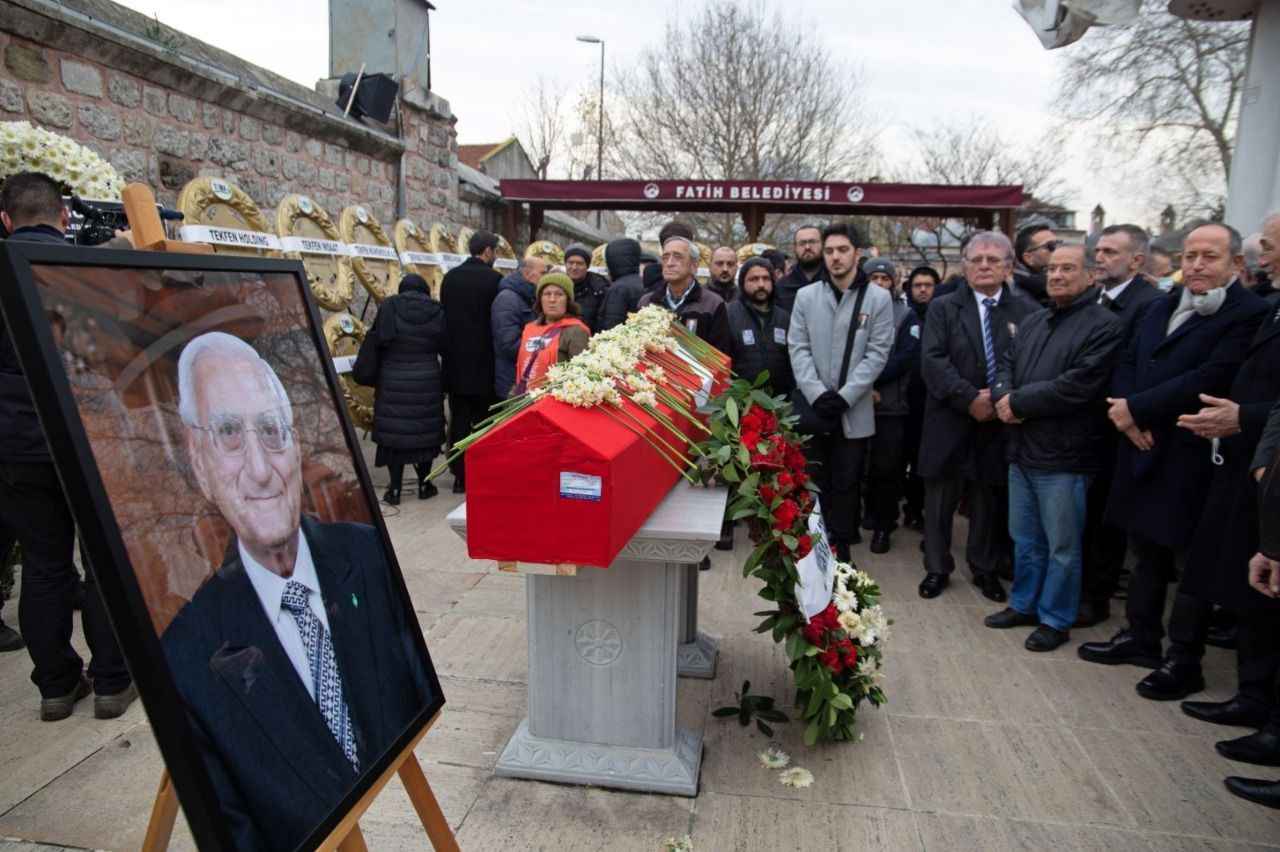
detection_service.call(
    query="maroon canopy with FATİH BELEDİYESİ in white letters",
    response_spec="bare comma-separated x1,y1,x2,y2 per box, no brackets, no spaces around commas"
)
498,180,1023,242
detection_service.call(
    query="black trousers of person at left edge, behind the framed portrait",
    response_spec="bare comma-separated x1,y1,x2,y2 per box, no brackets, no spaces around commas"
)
0,463,129,698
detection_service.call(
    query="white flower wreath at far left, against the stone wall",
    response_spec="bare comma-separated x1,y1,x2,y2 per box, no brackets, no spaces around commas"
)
0,122,124,201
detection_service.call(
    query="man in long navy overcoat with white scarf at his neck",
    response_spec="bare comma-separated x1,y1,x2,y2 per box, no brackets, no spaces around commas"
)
1079,224,1267,680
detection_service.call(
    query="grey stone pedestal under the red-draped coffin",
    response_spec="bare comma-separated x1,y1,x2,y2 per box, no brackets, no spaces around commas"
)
448,482,726,796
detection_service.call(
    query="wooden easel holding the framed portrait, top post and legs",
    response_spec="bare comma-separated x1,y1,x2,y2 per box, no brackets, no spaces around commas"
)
120,183,458,852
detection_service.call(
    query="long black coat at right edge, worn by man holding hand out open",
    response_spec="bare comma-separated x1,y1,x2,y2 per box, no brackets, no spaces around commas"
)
1183,305,1280,610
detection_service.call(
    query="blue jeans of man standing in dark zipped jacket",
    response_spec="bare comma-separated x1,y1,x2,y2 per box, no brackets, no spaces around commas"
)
1009,464,1089,631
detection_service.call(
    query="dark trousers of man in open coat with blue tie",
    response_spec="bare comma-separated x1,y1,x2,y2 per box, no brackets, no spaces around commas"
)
924,478,1012,577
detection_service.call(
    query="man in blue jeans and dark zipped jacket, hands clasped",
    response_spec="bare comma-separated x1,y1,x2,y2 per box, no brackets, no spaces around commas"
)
986,243,1121,651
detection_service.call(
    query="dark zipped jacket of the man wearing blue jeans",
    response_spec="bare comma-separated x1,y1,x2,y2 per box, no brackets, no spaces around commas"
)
991,287,1121,473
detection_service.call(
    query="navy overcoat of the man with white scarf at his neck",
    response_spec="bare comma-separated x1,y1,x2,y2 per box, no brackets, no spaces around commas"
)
1106,283,1267,548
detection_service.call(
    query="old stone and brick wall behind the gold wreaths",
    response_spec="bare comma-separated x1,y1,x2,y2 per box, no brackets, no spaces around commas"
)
0,0,466,228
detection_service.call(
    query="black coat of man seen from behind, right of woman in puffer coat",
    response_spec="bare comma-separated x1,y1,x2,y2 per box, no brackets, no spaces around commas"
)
440,257,502,398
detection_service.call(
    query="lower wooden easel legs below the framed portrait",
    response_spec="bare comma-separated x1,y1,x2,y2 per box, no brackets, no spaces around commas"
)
142,714,458,852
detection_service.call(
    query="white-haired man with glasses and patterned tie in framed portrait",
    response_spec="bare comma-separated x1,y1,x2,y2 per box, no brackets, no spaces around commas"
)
161,331,431,849
